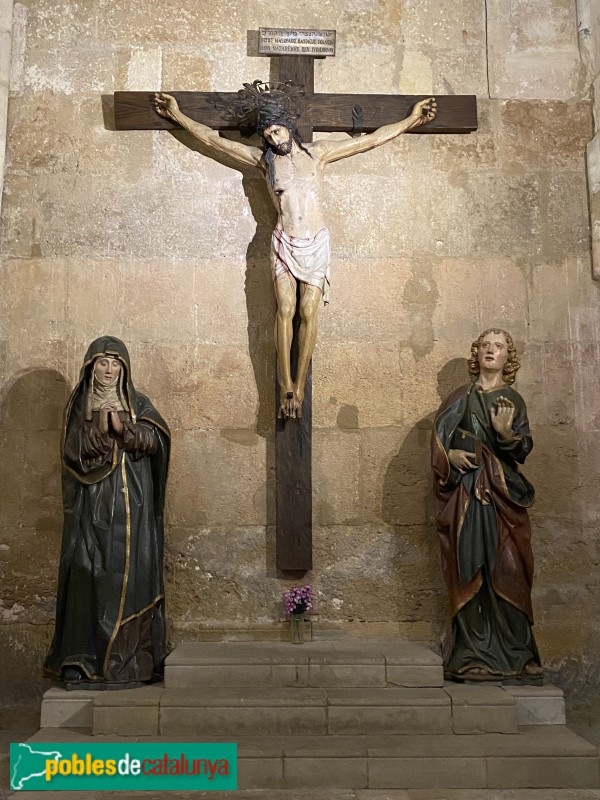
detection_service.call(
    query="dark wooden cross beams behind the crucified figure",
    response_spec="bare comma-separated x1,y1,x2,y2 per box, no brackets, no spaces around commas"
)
115,48,477,572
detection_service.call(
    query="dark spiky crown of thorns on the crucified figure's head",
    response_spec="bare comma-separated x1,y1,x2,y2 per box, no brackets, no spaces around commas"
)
218,81,304,133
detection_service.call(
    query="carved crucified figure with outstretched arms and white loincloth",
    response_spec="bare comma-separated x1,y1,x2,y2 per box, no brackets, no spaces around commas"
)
154,82,436,419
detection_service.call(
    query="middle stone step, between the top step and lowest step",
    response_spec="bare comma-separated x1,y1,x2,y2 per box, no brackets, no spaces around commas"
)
86,686,517,737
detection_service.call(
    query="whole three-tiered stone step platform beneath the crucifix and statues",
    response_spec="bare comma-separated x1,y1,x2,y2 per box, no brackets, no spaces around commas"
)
33,642,600,797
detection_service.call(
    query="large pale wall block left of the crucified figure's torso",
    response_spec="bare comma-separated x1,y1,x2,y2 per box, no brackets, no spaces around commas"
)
25,170,254,263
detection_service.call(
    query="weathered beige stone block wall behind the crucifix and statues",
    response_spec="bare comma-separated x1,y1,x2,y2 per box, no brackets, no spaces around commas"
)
0,0,600,698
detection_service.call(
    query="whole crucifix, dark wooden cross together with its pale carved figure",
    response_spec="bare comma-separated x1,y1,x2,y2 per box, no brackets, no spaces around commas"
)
115,28,477,572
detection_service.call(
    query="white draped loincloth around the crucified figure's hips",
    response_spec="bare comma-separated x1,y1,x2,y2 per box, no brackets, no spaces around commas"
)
271,228,330,305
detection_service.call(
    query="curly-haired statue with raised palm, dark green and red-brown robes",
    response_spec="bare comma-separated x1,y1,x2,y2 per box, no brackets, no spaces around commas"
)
432,328,543,684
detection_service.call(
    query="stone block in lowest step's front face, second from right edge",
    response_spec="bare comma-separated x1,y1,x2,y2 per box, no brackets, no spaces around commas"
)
369,757,488,789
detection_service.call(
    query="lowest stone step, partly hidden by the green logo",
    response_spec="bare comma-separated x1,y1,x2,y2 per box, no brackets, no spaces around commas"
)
24,725,600,800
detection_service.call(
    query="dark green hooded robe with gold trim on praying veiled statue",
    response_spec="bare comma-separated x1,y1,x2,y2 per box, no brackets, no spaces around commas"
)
44,337,170,683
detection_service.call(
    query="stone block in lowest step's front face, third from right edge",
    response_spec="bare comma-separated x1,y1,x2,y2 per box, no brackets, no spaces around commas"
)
284,757,369,789
